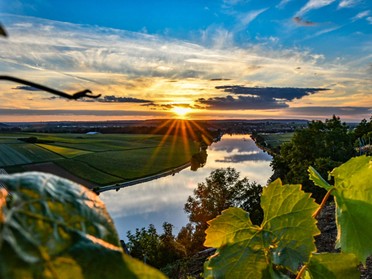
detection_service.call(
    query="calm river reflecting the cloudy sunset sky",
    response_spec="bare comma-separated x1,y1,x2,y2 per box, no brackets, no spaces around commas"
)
100,135,272,239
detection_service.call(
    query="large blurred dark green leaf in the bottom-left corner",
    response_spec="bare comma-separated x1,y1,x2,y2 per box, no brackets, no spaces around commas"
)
0,172,165,279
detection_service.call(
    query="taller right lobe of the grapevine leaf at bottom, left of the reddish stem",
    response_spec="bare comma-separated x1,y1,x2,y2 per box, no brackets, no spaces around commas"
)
261,180,319,271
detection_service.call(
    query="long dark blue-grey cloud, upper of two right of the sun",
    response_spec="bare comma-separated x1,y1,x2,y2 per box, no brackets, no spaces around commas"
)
216,85,329,101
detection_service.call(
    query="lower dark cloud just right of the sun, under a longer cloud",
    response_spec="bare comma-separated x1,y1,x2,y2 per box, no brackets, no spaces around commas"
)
196,95,288,110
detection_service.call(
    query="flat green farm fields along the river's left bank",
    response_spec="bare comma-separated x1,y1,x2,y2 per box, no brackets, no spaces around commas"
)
0,133,199,186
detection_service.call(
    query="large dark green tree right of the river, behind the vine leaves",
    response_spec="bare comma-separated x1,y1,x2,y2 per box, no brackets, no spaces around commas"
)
271,116,355,202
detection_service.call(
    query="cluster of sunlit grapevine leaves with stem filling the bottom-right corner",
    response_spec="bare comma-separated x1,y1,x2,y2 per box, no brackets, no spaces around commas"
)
205,156,372,278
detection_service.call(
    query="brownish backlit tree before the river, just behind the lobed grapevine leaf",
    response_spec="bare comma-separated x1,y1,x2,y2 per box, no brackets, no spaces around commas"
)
180,168,262,252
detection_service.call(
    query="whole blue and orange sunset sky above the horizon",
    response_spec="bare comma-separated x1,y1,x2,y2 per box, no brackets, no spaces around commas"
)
0,0,372,122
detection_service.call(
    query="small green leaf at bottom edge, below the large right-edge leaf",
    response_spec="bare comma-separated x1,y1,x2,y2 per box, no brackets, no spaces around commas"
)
302,253,360,279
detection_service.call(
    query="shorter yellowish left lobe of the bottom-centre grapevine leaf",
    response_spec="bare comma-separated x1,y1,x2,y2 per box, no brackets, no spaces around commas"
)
204,208,268,278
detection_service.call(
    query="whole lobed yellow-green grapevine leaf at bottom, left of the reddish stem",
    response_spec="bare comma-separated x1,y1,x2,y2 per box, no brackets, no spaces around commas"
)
205,180,319,278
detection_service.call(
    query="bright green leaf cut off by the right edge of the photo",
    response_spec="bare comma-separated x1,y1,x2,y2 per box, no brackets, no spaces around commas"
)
331,156,372,263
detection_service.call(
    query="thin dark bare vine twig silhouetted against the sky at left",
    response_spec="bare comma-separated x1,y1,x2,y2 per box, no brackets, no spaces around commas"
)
0,76,101,100
